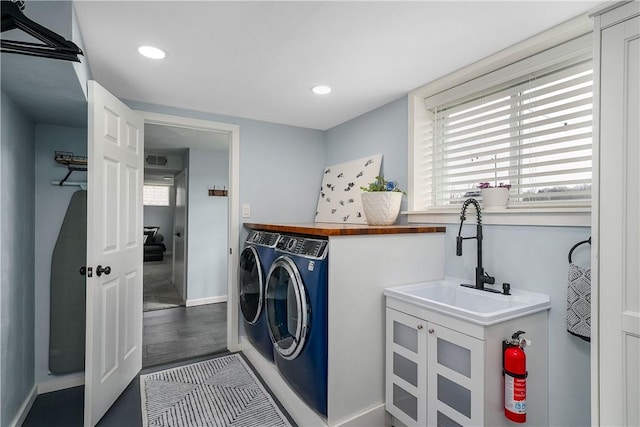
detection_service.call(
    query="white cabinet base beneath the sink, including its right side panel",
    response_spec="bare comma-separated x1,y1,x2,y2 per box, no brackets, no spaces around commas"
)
385,291,549,426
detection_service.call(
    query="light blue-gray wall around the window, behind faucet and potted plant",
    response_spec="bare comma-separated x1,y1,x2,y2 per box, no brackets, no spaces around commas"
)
326,97,591,426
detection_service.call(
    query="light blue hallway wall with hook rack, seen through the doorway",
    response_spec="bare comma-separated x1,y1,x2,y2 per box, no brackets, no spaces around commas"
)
187,148,229,300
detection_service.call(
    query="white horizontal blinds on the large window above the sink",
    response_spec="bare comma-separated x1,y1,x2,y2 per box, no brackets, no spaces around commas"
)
416,37,593,208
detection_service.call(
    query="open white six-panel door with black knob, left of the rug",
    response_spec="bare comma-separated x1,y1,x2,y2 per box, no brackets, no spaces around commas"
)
84,81,144,426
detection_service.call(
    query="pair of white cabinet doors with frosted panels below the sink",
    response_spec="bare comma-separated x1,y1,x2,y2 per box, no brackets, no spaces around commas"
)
386,308,484,426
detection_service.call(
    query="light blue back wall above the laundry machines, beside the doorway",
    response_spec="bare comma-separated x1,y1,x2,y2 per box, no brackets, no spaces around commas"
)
126,101,324,234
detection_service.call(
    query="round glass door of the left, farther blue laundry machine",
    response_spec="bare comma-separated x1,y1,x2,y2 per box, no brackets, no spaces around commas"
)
238,246,265,325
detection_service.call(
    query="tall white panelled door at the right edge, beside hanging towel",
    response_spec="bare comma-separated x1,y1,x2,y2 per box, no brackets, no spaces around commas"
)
596,2,640,426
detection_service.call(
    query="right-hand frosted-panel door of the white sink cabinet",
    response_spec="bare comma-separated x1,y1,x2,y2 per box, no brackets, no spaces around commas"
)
427,323,485,427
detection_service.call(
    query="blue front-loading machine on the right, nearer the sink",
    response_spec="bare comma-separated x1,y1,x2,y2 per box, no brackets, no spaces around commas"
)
265,235,328,417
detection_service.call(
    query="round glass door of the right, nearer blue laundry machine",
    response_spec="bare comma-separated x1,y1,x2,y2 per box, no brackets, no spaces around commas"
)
265,256,310,360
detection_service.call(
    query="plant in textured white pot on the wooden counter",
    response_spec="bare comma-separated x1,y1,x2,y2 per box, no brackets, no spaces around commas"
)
360,176,405,225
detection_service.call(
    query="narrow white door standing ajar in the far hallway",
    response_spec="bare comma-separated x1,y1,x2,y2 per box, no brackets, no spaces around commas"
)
173,169,188,301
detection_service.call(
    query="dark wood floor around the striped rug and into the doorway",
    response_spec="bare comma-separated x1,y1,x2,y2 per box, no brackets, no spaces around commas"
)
23,303,227,427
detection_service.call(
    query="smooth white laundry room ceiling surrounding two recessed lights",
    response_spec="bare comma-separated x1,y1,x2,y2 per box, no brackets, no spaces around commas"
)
72,1,600,130
